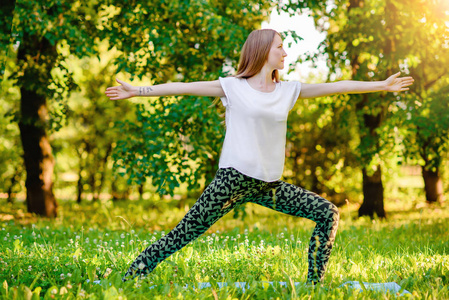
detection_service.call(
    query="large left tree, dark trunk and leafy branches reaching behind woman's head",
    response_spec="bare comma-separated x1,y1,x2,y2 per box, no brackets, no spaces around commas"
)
6,0,288,216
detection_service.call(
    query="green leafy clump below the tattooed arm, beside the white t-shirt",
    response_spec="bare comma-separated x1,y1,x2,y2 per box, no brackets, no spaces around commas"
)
114,97,224,193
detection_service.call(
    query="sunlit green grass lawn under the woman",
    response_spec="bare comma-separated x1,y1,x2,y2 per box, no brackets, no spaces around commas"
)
0,201,449,299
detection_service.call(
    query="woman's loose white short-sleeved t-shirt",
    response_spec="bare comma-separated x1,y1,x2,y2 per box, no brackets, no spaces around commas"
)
219,77,301,182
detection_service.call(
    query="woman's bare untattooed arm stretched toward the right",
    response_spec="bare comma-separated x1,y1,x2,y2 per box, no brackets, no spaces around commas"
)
299,72,414,98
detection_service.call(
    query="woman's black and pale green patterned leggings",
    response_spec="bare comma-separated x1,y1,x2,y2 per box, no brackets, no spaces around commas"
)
124,168,339,283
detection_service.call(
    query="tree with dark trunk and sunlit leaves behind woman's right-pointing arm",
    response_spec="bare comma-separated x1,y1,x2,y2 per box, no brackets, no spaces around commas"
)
290,0,448,217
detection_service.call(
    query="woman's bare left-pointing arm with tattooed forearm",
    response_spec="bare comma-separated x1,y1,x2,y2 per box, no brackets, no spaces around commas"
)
105,79,225,100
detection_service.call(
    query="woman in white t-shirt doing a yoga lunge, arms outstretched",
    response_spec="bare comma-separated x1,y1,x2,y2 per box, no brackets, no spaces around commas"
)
106,29,413,283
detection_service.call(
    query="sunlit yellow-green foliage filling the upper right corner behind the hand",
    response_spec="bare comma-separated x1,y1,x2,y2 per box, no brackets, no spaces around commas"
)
287,0,449,205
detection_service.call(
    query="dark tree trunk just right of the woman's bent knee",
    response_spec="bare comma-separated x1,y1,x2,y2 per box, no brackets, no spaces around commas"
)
359,166,386,218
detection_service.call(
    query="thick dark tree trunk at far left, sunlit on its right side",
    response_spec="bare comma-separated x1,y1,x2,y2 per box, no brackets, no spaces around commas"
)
18,36,57,217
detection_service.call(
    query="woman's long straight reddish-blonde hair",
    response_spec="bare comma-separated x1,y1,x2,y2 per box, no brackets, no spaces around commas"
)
235,29,281,82
